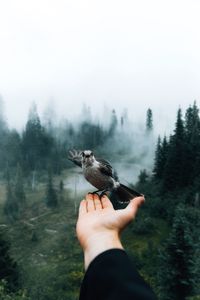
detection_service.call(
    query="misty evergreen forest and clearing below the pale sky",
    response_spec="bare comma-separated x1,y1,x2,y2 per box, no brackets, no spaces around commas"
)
0,100,200,300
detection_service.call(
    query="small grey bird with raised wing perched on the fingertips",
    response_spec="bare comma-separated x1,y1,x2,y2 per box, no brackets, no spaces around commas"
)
68,149,144,203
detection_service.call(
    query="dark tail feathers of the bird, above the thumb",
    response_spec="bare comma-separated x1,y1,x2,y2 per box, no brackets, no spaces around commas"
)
112,183,143,203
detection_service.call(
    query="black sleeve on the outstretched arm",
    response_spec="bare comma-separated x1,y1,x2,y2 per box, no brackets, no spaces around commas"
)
79,249,157,300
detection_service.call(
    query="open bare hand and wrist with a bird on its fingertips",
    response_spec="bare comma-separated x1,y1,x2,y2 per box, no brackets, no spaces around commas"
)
76,194,144,269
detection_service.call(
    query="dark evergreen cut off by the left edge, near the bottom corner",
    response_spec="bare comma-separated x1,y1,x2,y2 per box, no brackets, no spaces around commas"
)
0,233,19,291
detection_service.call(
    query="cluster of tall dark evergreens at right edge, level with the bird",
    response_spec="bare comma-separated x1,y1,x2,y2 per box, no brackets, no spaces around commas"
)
154,103,200,193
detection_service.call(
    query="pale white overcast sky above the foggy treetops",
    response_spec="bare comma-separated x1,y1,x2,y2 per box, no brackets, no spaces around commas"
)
0,0,200,132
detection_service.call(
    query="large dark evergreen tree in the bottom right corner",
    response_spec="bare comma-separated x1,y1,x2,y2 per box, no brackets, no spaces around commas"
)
158,205,198,300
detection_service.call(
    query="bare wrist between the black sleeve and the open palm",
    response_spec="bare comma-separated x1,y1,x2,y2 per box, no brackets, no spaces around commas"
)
83,232,123,270
